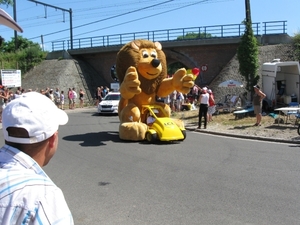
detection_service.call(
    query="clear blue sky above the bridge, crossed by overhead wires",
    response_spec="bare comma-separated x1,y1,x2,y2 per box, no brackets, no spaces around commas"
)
0,0,300,50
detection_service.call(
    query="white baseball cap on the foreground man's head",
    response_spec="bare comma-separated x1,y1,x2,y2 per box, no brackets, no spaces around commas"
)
2,92,69,144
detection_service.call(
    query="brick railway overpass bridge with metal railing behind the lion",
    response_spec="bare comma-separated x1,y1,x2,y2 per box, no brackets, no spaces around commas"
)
47,21,290,100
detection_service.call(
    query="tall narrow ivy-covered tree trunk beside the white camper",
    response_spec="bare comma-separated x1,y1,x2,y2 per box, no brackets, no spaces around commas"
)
237,1,259,96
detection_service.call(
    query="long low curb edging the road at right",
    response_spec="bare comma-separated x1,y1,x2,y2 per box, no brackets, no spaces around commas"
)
185,127,300,144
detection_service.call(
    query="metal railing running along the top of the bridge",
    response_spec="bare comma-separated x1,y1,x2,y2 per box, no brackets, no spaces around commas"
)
52,21,287,51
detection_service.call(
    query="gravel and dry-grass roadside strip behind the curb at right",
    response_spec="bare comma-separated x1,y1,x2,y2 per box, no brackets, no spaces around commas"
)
179,110,300,144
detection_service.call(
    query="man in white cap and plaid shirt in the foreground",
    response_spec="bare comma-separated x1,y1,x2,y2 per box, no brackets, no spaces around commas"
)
0,92,74,225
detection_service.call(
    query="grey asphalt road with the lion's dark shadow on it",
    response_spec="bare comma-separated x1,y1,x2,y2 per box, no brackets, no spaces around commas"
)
0,109,300,225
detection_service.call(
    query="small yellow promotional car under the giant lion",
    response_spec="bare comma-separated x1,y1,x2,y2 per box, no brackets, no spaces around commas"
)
142,105,186,143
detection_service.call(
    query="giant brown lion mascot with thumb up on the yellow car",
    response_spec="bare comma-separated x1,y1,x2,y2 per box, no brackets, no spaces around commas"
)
116,40,194,141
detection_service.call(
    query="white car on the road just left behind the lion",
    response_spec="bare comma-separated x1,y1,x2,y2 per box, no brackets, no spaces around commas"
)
98,92,121,114
